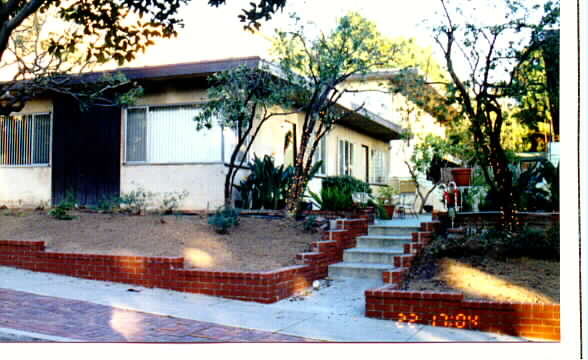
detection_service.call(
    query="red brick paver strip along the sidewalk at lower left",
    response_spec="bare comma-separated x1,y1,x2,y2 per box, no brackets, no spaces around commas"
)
0,289,316,343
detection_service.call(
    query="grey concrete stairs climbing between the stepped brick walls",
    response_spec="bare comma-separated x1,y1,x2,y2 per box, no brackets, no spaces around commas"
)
329,225,419,279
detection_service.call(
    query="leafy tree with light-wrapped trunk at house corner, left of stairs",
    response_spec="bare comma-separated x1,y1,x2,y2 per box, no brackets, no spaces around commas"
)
274,13,398,217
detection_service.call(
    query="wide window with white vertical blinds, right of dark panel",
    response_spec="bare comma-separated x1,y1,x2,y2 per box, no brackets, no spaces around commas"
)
126,105,224,164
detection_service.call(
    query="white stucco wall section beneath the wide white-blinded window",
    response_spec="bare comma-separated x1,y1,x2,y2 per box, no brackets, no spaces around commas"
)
120,163,225,210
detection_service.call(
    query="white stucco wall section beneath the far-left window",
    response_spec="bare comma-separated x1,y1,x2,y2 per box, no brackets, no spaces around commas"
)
0,166,51,208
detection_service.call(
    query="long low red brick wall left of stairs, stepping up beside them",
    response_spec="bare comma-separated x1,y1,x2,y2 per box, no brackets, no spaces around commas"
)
0,219,368,303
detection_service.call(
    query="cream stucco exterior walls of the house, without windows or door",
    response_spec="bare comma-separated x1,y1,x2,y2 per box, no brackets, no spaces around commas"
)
0,85,400,210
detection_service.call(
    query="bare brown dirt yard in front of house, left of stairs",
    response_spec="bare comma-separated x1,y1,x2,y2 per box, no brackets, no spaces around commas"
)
0,209,319,271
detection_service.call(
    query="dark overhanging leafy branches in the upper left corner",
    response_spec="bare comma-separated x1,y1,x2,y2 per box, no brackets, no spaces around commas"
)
0,0,286,115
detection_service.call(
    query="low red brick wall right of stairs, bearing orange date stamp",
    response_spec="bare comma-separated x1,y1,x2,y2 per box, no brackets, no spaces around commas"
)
365,285,560,341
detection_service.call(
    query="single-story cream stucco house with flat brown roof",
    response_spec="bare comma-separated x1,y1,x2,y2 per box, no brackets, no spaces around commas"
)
0,57,401,210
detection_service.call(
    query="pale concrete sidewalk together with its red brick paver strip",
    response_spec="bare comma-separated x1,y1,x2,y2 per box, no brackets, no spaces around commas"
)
0,267,527,342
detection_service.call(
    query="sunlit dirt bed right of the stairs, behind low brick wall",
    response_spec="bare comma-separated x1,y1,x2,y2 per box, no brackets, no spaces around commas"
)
403,256,560,304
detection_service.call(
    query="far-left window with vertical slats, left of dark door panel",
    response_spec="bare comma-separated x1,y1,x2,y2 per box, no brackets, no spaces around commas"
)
0,114,51,166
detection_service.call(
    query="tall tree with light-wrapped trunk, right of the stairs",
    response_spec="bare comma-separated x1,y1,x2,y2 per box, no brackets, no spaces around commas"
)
435,0,559,220
